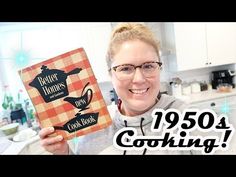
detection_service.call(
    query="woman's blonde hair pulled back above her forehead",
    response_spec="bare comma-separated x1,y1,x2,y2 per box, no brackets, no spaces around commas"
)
106,23,160,69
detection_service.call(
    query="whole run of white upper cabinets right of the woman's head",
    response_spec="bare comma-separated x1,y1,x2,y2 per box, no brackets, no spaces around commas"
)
163,23,236,71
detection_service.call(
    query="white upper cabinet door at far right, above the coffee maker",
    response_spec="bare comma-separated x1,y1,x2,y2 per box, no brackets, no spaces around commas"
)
206,23,236,66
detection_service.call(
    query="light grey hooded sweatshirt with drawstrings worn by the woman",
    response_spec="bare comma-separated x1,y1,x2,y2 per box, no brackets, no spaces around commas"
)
72,95,190,154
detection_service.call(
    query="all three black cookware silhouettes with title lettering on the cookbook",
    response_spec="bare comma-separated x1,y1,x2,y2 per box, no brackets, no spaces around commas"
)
29,65,99,133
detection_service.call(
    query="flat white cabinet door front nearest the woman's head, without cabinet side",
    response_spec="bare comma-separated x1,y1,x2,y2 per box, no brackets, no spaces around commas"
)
174,23,207,70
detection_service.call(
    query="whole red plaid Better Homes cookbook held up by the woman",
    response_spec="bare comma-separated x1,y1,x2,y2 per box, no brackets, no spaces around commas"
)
19,48,112,140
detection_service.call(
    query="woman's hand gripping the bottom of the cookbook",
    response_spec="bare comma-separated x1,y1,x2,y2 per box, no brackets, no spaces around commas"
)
39,127,69,155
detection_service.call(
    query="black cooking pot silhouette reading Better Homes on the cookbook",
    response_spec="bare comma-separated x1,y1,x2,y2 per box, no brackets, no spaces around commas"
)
29,65,82,103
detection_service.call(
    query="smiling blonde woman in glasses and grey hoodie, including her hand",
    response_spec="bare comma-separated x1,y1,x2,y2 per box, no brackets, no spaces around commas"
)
39,23,190,154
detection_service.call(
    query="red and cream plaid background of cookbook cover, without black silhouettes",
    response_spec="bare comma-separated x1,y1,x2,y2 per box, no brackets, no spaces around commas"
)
19,48,112,140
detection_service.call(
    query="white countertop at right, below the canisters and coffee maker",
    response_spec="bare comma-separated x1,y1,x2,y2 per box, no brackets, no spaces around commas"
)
178,88,236,104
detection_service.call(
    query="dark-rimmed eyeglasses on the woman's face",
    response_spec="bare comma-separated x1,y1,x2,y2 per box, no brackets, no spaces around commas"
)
110,61,162,80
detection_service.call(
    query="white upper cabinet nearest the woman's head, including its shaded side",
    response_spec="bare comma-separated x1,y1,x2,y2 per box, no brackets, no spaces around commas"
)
163,23,207,71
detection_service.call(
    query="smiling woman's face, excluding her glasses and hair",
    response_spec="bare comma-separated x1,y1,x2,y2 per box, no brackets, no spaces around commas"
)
111,40,160,116
